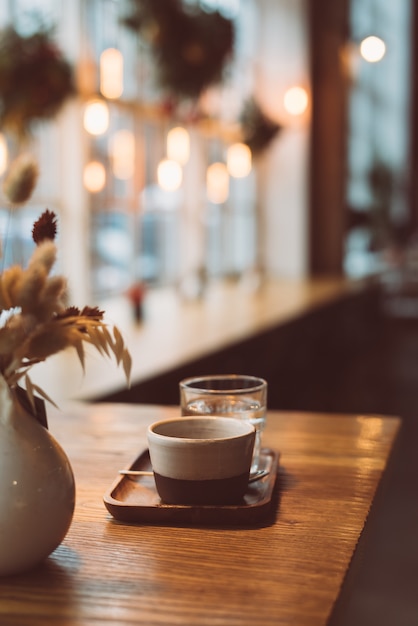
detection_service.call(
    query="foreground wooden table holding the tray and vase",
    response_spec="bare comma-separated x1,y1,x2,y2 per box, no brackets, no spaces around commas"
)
0,404,400,626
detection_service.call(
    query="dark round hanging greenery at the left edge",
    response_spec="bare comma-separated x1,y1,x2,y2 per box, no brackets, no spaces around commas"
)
0,27,75,136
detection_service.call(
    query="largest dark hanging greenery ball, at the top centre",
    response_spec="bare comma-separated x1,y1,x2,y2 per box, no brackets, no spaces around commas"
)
123,0,234,99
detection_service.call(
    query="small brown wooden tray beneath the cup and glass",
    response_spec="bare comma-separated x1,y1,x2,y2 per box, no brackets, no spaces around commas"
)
103,448,279,525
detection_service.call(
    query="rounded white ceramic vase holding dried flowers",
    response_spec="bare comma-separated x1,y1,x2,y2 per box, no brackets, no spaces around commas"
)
0,378,75,576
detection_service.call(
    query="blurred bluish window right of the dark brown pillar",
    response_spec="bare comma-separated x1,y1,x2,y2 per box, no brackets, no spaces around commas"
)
345,0,411,276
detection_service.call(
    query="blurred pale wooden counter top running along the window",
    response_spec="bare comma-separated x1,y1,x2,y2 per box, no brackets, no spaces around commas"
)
31,279,363,403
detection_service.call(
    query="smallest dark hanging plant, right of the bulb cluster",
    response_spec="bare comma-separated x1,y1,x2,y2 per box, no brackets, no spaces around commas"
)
240,98,282,155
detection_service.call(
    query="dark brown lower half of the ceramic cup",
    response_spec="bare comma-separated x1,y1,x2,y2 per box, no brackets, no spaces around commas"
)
154,472,249,505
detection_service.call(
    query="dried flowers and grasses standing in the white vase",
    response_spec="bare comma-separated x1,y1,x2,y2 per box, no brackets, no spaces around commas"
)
0,156,131,411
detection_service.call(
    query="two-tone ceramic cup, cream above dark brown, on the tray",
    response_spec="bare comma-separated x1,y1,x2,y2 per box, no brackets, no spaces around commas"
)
147,416,255,505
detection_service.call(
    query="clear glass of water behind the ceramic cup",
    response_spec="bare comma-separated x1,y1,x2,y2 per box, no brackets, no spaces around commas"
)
180,374,267,472
